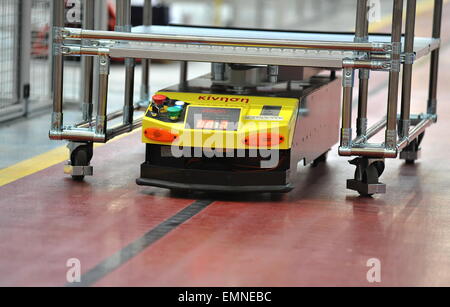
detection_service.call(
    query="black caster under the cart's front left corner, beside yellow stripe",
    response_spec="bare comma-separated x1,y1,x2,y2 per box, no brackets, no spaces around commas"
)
64,142,94,181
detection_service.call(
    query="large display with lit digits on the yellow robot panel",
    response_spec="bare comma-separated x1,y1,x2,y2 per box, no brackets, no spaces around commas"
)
186,106,241,131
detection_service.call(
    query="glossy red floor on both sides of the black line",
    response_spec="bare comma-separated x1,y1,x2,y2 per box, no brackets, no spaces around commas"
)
0,5,450,286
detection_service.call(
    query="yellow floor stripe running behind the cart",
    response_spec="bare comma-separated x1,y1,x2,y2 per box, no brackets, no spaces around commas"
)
0,0,444,187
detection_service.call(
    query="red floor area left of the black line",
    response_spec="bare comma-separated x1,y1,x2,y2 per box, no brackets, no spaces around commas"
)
0,133,197,285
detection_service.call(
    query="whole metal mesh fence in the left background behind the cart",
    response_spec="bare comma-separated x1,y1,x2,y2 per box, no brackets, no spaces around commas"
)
0,0,82,121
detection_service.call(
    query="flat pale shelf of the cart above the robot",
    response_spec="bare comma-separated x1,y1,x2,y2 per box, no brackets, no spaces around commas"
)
97,26,440,68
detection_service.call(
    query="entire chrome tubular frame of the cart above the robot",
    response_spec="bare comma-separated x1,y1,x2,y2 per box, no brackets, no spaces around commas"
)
50,0,443,180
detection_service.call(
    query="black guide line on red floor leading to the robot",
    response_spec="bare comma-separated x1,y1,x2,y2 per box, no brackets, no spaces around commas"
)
66,200,214,287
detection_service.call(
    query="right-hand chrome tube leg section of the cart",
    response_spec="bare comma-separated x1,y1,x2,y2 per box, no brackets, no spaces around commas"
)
339,0,442,158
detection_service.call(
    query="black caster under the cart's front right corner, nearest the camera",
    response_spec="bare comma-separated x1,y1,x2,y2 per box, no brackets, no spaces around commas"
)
347,157,386,196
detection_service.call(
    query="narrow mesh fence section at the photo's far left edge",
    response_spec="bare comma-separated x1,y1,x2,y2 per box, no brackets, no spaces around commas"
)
0,0,19,109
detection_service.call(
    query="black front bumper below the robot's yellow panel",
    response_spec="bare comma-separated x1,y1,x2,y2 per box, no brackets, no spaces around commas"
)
136,144,293,193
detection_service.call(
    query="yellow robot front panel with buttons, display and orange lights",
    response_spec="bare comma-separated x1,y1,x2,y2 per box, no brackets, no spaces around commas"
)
142,92,299,149
